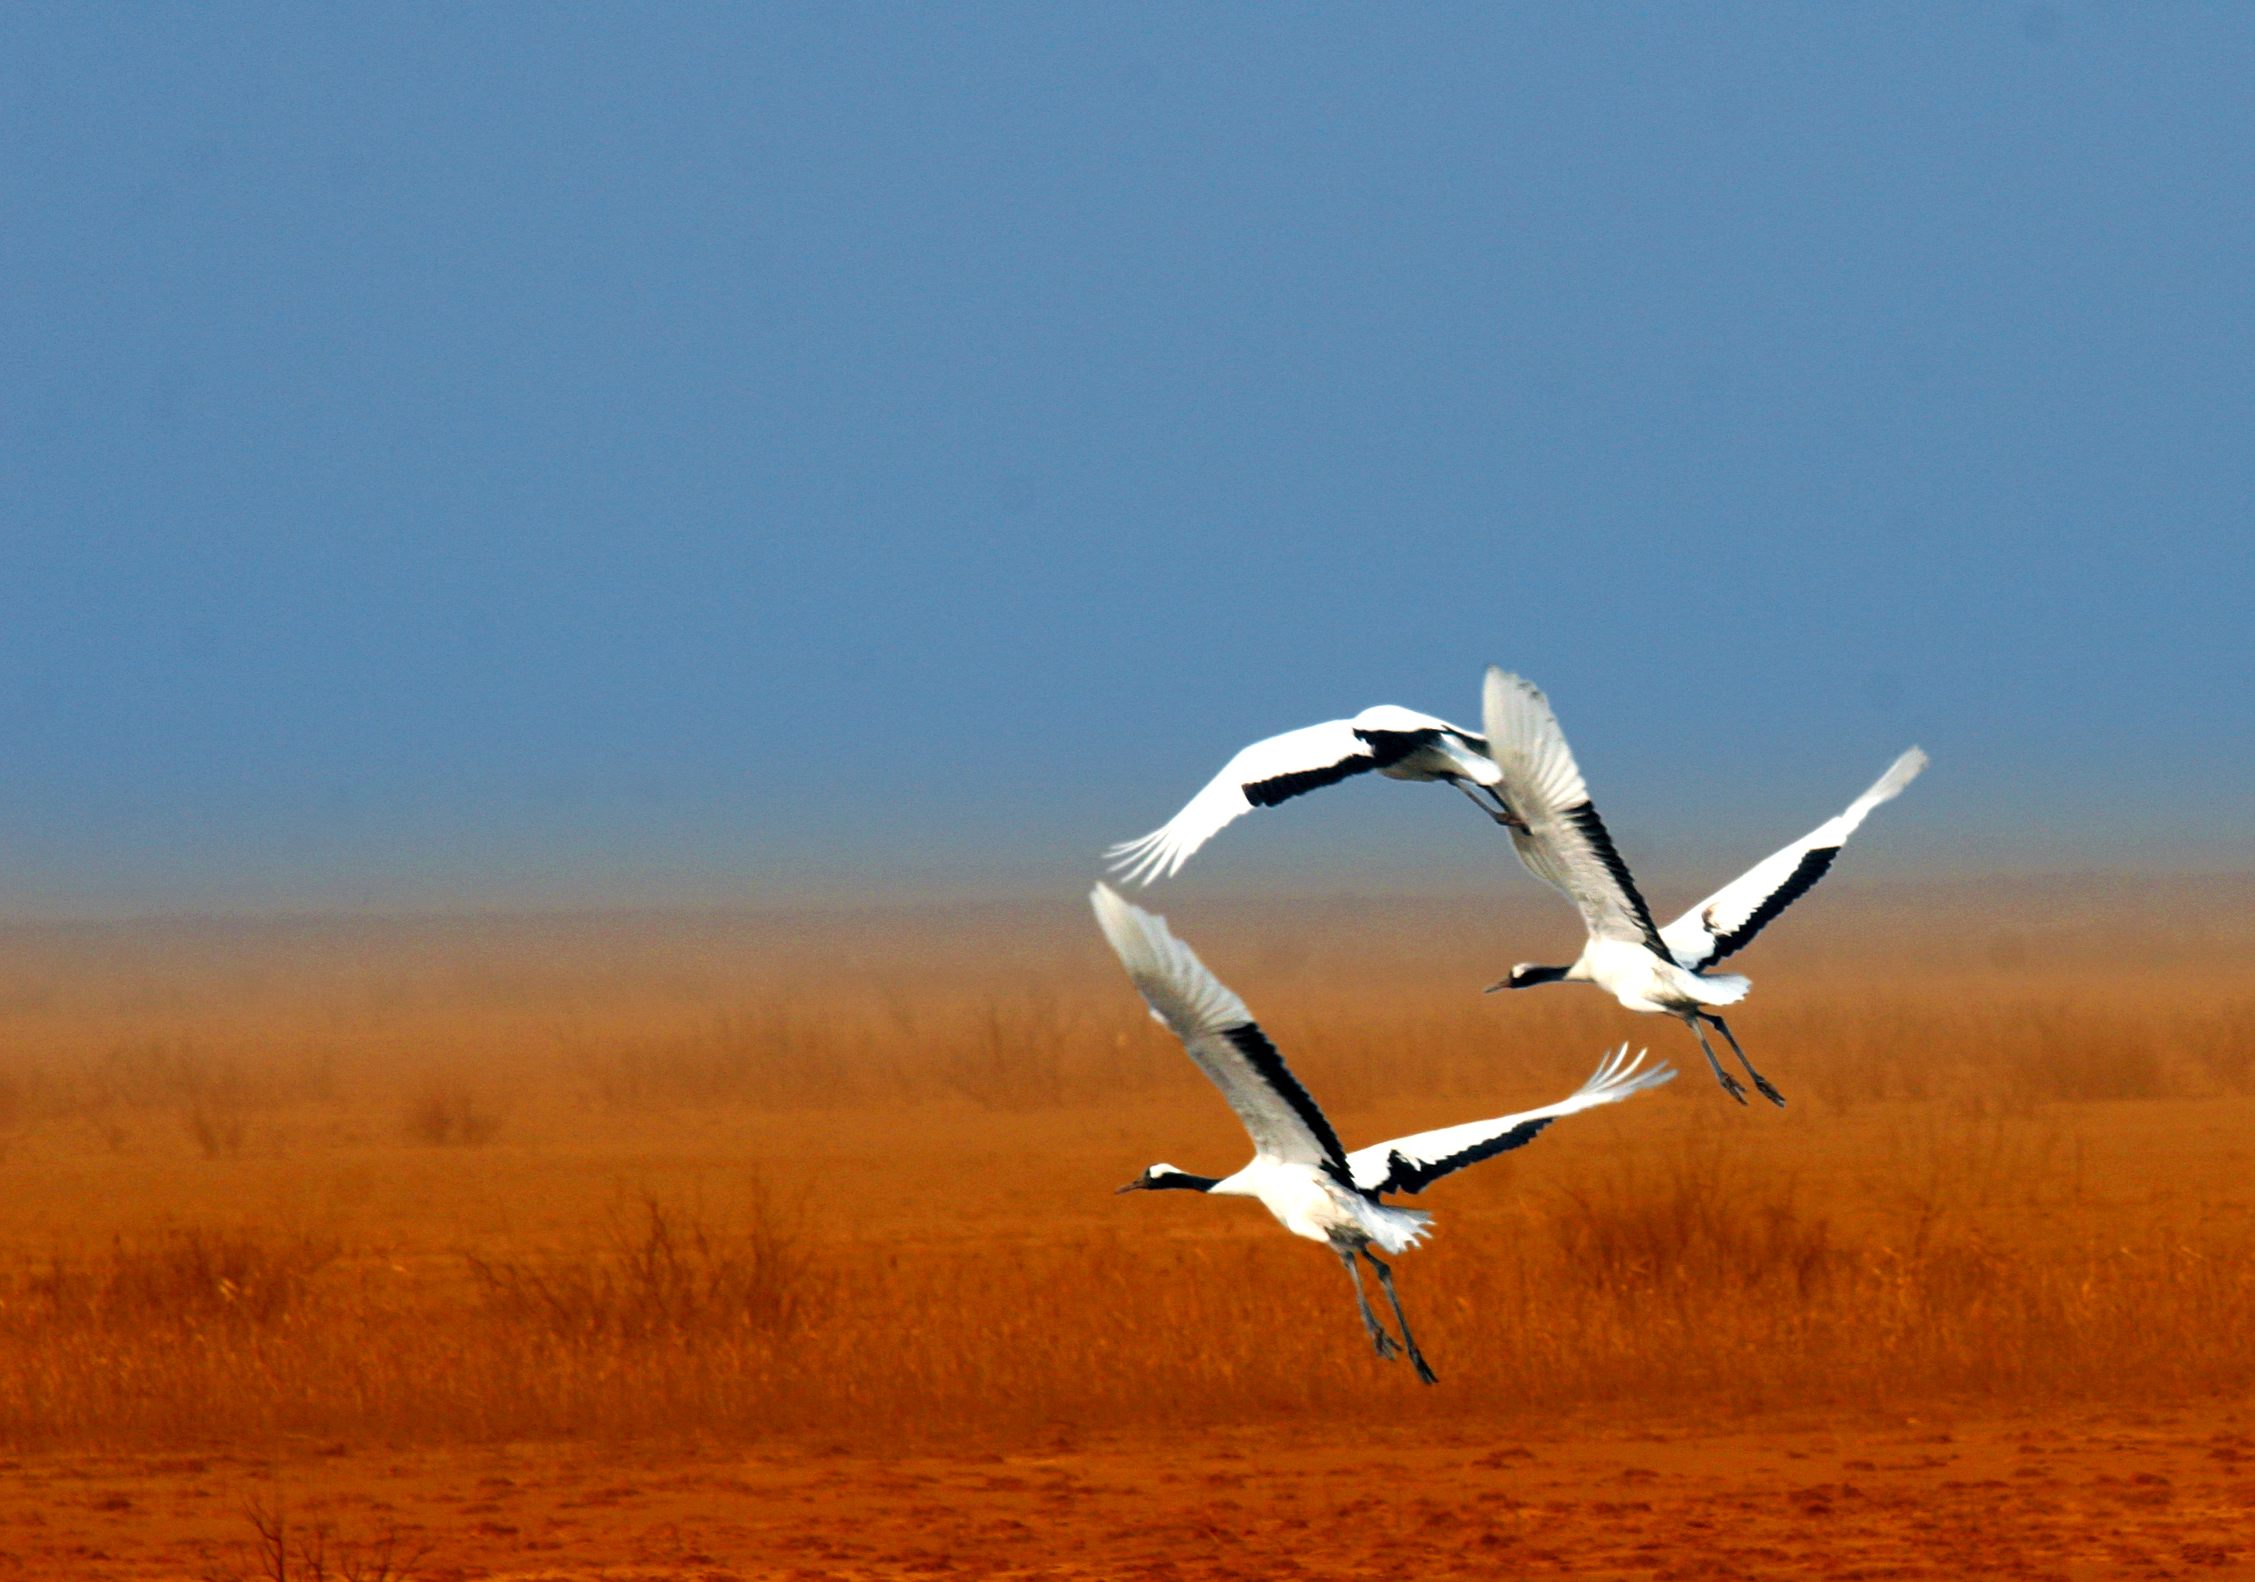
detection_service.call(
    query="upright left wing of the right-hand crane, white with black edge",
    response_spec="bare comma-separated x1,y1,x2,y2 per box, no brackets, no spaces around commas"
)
1484,665,1666,956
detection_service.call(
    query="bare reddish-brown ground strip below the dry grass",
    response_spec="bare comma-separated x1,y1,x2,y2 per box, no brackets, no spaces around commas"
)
13,1411,2255,1582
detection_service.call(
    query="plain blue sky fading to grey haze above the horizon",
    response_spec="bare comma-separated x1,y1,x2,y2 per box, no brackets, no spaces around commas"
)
0,0,2255,915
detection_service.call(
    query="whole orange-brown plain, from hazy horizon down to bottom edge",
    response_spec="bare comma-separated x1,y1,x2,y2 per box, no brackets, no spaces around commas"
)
0,881,2255,1577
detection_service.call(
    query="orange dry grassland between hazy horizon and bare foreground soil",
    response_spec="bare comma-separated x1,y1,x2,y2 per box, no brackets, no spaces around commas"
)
0,881,2255,1447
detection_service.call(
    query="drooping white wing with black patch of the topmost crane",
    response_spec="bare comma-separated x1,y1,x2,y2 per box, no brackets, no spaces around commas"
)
1105,703,1479,883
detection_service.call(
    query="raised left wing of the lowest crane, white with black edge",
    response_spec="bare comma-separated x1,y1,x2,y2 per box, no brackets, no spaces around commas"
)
1089,883,1346,1183
